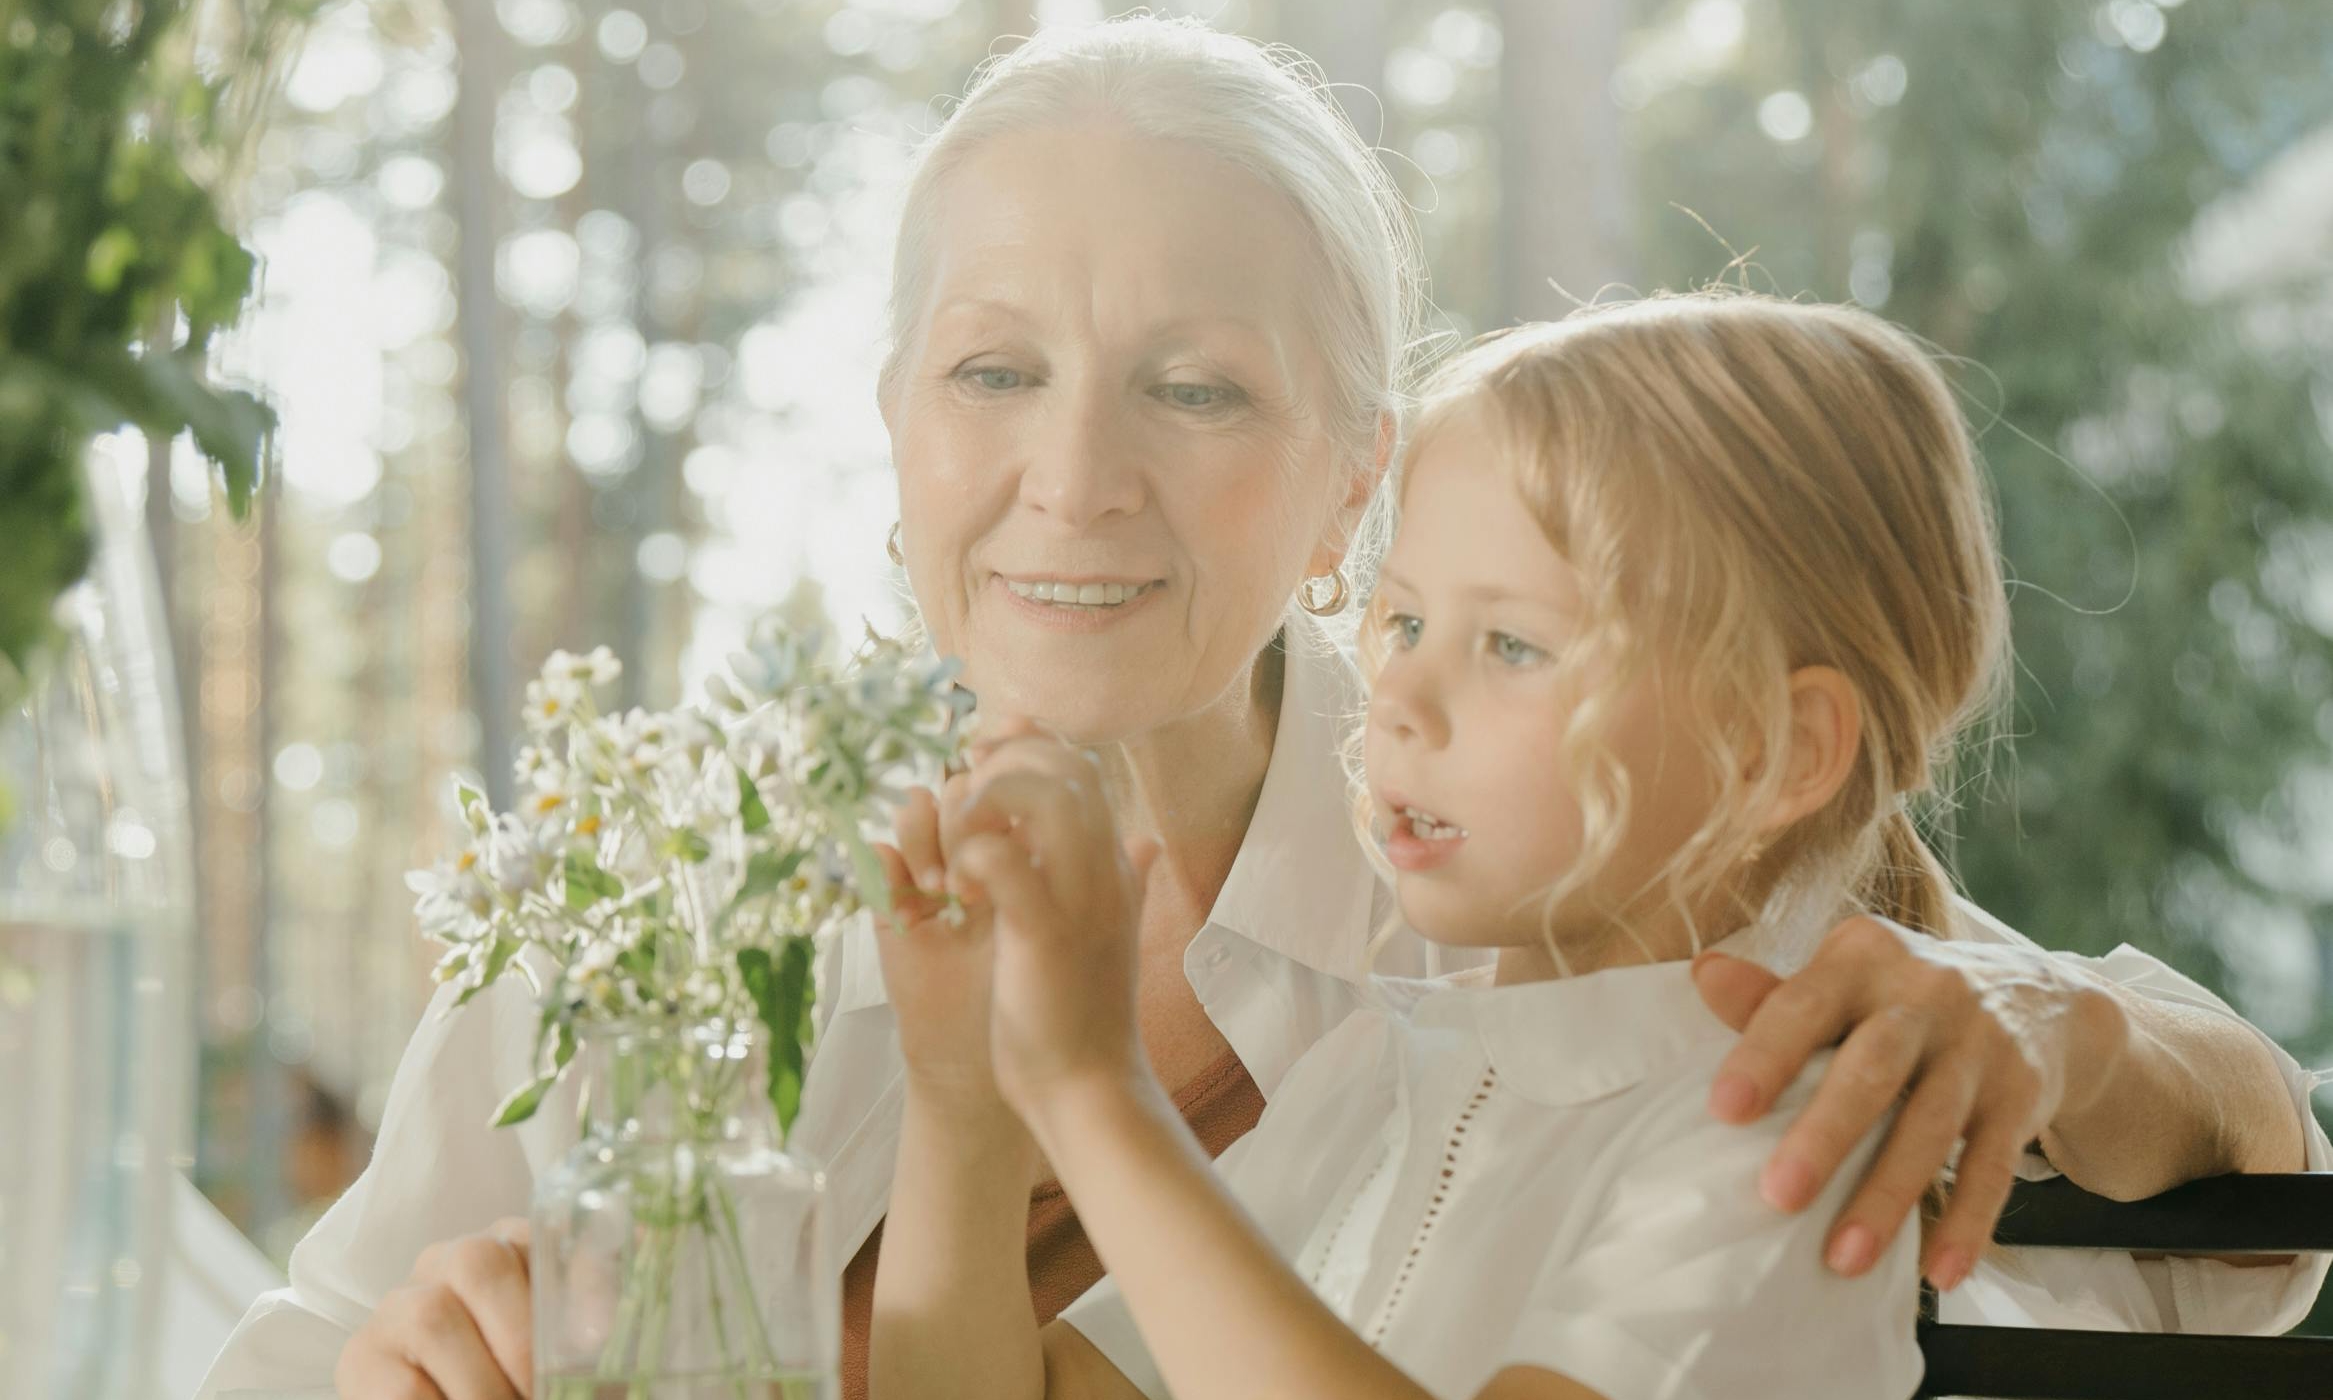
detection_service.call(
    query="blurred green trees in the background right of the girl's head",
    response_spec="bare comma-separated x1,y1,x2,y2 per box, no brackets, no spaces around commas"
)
1633,0,2333,1073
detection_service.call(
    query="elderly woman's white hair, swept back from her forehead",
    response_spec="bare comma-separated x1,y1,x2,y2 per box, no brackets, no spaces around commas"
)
882,14,1425,625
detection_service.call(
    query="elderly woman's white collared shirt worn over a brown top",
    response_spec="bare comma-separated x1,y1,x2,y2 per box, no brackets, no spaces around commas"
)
201,611,2333,1398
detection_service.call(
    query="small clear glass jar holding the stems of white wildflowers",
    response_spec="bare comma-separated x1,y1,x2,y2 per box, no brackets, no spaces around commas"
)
530,1022,842,1400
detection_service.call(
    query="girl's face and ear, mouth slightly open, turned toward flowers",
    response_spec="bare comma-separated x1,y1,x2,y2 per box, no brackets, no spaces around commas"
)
1367,403,1717,980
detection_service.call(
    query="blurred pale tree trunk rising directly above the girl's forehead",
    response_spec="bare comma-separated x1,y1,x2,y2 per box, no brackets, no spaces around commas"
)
1498,0,1635,320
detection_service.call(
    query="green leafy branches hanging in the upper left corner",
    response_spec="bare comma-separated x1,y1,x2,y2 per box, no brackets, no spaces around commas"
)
0,0,315,695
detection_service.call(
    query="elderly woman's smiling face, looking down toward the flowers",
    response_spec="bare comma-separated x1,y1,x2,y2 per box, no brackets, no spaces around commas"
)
884,126,1353,742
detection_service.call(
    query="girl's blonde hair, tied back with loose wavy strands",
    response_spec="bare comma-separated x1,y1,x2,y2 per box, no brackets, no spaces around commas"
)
1362,292,2009,945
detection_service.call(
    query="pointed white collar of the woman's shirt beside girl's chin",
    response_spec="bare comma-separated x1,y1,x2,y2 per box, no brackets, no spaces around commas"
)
1208,614,1379,982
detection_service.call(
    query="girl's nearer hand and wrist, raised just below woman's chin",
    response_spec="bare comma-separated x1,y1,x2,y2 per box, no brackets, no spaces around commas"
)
943,730,1157,1127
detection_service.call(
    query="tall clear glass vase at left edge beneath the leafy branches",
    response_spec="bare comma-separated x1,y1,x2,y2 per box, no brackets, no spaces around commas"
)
0,453,194,1400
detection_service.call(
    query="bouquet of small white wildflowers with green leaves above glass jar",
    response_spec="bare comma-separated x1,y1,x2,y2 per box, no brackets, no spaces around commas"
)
406,623,971,1132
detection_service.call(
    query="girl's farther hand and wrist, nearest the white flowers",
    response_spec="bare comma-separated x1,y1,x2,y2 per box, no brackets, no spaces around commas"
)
875,775,1008,1115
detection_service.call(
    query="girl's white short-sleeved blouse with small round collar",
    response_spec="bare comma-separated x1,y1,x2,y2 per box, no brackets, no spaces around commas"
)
1062,961,1920,1400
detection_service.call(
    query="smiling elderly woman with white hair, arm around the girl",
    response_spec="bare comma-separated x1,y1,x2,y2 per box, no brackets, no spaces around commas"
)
205,19,2328,1400
